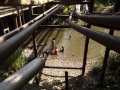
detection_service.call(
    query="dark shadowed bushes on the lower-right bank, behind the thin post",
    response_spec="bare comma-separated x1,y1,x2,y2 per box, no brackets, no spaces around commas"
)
89,51,120,90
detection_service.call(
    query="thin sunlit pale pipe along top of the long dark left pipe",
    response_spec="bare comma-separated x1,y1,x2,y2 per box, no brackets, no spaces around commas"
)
0,5,58,44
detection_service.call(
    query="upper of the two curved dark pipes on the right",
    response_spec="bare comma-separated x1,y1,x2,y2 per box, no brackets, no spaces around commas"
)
75,11,120,29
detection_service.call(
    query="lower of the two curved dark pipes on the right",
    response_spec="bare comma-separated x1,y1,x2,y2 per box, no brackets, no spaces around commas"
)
68,8,120,53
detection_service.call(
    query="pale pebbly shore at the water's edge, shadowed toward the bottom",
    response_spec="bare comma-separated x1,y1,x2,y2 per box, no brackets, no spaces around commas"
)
22,51,96,90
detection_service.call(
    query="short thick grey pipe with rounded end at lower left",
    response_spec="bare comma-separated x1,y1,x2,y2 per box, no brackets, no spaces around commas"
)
0,58,45,90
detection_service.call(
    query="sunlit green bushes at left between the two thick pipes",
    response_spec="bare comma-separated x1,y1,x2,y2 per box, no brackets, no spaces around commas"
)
0,48,27,78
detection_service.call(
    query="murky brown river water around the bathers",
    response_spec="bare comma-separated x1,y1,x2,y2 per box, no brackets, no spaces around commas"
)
32,26,120,61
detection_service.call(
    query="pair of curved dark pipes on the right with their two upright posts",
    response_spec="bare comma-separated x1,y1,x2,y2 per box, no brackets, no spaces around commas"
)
68,0,120,81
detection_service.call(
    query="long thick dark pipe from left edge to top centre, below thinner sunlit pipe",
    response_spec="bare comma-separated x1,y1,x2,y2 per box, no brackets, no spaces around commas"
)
0,5,62,65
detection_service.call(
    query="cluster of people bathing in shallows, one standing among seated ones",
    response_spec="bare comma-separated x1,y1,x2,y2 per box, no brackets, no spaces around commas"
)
43,38,64,57
